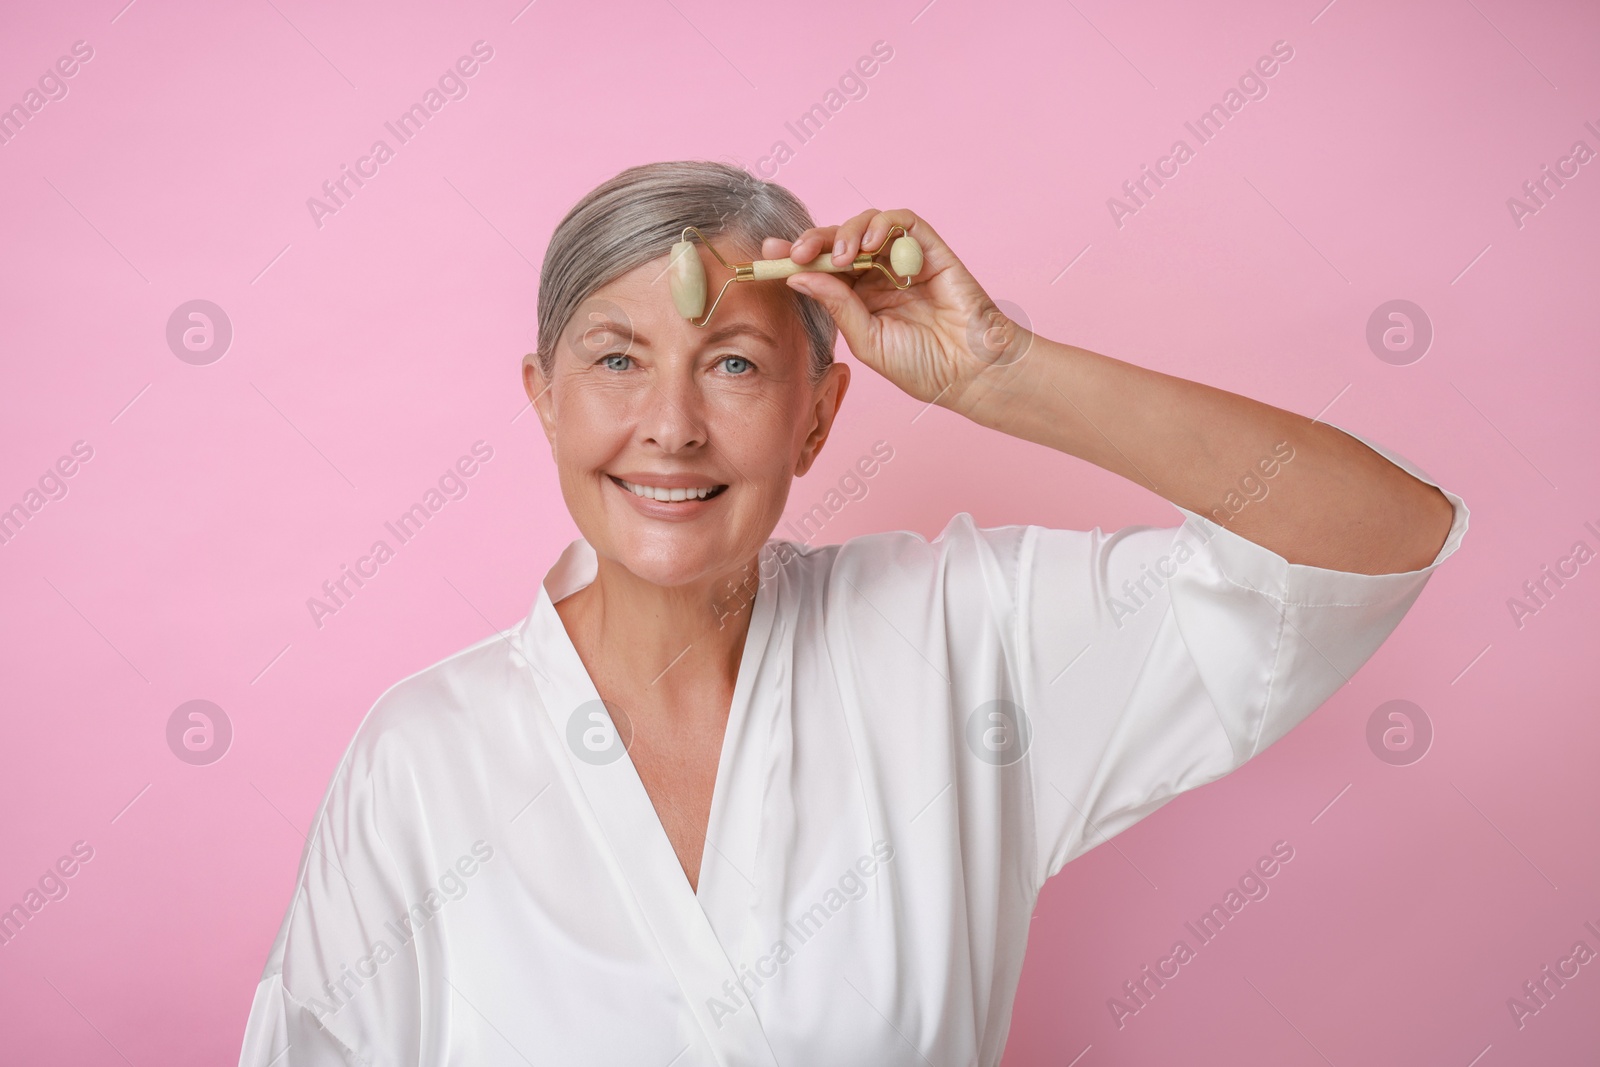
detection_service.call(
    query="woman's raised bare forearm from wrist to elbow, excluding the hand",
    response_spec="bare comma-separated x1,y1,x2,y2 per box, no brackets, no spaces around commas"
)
941,340,1454,574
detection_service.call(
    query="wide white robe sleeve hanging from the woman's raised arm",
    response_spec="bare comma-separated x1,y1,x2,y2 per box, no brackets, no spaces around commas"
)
1017,422,1469,888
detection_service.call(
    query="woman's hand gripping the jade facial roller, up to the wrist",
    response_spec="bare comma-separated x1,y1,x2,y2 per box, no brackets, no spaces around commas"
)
762,208,1032,405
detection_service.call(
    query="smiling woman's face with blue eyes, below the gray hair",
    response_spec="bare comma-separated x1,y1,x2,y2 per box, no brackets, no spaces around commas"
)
523,238,850,589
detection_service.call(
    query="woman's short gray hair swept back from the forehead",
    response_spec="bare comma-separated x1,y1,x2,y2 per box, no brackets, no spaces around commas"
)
534,160,837,384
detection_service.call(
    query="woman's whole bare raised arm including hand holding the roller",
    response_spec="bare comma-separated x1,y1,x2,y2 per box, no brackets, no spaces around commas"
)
780,210,1453,574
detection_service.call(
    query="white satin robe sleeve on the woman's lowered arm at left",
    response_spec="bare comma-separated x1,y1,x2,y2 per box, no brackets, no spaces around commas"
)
238,715,422,1067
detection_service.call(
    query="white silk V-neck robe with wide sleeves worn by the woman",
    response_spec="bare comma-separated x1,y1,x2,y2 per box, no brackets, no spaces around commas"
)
240,428,1467,1067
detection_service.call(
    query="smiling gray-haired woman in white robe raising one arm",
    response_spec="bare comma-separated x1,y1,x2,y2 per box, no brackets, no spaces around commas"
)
240,162,1467,1067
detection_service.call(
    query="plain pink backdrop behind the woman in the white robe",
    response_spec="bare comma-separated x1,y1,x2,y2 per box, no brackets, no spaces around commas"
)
0,0,1600,1067
